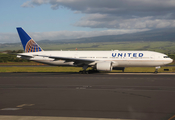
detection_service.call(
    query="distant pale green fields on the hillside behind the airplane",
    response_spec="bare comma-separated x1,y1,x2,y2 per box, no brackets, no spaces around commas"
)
0,41,175,54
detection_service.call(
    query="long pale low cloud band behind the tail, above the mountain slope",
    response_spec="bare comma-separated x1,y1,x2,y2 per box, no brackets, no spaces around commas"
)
0,29,147,43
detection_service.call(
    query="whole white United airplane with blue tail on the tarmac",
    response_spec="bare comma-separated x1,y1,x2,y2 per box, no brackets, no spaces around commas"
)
16,27,173,74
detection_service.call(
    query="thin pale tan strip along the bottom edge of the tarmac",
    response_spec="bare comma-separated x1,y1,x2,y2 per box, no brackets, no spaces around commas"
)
0,115,134,120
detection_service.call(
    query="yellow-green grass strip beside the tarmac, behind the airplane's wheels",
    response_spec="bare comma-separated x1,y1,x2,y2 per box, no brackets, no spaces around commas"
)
0,66,175,73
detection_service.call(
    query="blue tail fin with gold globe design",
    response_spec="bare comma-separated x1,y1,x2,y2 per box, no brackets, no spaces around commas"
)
16,27,43,52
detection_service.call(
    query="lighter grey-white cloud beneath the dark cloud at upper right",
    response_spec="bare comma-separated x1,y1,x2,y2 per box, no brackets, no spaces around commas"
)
75,14,175,29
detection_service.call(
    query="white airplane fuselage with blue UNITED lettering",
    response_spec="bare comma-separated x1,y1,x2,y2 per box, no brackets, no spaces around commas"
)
18,50,172,67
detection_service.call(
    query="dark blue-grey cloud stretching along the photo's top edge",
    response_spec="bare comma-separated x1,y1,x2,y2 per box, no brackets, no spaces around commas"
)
22,0,175,16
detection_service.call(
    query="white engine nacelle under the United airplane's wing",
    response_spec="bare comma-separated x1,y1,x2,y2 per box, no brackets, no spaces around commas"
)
96,61,112,71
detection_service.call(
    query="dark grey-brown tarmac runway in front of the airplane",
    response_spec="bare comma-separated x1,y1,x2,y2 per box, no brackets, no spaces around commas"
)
0,73,175,120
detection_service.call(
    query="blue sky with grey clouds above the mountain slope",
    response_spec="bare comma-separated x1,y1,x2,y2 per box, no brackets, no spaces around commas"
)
0,0,175,43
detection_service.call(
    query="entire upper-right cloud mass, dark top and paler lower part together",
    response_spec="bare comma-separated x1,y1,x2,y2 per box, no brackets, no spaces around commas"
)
22,0,175,29
